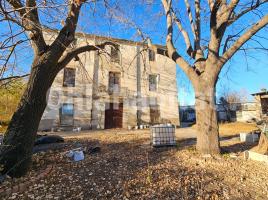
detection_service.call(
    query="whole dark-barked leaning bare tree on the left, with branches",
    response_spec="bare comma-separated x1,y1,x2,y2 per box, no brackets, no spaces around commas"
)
0,0,117,176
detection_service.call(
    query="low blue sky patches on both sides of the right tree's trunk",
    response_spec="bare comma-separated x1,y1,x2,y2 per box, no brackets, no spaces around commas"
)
177,44,268,105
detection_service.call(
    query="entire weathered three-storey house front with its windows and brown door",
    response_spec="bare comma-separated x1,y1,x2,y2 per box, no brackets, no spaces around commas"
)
39,31,179,130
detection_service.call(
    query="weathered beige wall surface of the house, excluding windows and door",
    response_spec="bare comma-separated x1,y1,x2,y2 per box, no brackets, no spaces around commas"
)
39,31,179,130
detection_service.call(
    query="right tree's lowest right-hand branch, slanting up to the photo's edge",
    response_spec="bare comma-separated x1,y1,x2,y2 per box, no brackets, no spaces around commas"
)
220,15,268,66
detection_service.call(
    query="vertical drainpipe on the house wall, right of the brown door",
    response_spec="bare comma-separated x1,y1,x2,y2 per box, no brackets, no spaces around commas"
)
136,46,142,126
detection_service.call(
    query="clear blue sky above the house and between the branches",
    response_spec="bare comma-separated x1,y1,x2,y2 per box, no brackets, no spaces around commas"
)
0,0,268,105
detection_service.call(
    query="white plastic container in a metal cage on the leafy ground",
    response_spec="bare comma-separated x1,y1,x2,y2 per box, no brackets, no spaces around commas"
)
151,124,176,147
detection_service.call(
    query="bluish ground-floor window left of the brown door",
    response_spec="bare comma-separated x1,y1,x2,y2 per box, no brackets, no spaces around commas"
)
60,103,74,126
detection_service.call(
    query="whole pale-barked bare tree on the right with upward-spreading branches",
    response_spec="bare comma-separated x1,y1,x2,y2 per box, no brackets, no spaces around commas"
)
149,0,268,154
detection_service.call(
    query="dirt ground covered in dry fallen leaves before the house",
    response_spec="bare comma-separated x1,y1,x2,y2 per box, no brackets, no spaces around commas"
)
0,124,268,200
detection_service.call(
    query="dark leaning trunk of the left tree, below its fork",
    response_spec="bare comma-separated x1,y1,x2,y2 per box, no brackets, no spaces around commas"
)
0,59,56,177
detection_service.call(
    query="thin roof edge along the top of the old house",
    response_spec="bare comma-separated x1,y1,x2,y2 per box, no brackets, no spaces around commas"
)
43,28,167,49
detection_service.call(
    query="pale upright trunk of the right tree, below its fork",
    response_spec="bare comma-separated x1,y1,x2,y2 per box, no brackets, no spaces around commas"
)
195,80,220,154
